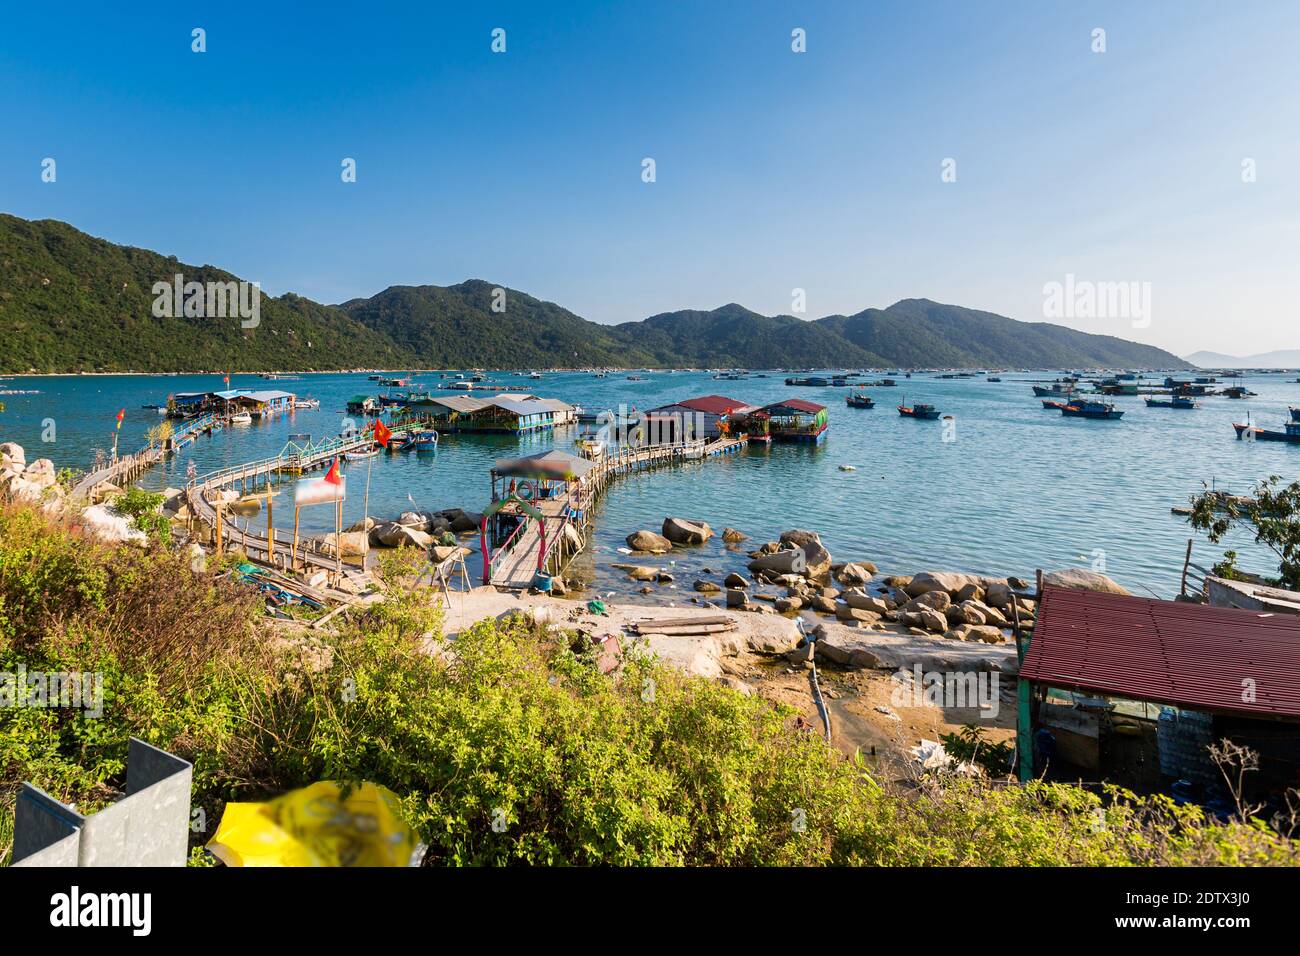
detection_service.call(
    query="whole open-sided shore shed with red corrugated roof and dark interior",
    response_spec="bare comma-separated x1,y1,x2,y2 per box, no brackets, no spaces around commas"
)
1018,587,1300,799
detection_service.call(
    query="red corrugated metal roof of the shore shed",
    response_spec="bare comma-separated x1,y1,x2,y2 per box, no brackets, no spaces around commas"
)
1021,587,1300,717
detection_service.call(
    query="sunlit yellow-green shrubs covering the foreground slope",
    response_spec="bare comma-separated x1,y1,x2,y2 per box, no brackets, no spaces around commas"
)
0,509,1297,865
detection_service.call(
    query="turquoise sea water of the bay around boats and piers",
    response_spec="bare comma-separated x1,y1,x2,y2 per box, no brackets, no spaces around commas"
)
0,372,1300,597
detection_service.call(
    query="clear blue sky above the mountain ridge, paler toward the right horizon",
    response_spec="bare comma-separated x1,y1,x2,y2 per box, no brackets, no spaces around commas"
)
0,0,1300,354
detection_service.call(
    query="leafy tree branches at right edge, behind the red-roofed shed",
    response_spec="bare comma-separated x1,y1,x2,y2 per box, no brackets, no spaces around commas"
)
1187,475,1300,591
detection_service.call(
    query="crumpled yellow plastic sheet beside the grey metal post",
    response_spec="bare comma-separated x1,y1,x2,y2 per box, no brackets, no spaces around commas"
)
208,780,417,866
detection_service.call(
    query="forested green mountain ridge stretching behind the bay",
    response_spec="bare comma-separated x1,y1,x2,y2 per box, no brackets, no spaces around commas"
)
0,215,1191,373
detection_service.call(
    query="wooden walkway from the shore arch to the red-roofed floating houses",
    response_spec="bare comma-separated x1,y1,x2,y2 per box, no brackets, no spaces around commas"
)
489,437,748,591
